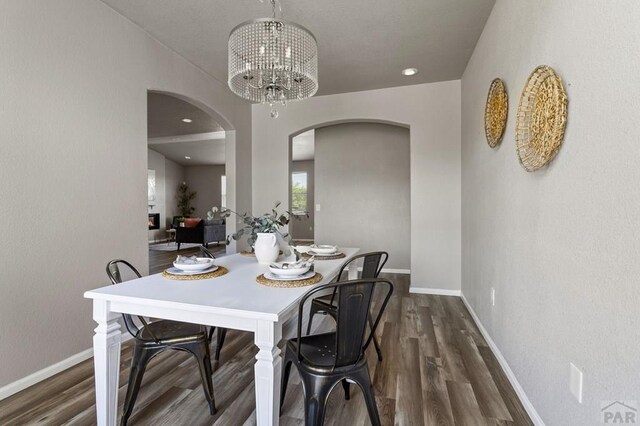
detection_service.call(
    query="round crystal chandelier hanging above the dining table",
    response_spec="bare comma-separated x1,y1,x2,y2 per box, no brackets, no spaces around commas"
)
228,0,318,118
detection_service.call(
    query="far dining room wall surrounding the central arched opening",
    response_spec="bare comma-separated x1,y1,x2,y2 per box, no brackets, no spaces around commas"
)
251,81,461,290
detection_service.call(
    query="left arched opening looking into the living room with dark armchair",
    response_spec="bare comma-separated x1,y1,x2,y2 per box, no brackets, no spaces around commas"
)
147,90,235,267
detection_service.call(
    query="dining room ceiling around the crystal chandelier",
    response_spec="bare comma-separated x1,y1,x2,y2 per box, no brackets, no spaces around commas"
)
102,0,495,95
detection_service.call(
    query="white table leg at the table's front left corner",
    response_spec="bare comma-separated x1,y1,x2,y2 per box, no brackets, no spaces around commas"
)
93,299,122,426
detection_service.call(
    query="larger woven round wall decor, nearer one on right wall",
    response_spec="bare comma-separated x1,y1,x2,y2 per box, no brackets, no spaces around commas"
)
516,65,568,172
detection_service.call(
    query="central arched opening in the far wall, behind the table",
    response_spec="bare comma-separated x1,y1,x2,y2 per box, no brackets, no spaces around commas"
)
289,120,411,269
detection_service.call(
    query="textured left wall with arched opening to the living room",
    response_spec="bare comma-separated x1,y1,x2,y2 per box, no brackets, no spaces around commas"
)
0,0,251,386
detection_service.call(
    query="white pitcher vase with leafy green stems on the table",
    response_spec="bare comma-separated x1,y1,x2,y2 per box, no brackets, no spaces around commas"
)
207,202,301,264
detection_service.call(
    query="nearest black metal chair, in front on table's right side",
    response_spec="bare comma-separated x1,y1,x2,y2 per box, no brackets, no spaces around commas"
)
280,278,393,426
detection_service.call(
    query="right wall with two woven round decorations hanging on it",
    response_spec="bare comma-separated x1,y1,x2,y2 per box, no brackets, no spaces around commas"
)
462,0,640,425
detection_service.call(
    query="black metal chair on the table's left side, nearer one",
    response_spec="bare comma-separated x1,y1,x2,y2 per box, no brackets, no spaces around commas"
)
106,259,216,426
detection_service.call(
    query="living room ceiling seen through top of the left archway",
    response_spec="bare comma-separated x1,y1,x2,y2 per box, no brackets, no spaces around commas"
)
147,92,225,166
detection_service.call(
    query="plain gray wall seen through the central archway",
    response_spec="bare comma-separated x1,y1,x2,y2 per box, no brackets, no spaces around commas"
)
315,123,411,269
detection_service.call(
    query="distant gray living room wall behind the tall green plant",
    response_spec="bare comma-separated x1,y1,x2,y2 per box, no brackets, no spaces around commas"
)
184,166,224,219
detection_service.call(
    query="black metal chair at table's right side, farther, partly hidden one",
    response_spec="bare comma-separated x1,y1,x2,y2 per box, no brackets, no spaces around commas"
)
307,251,389,361
